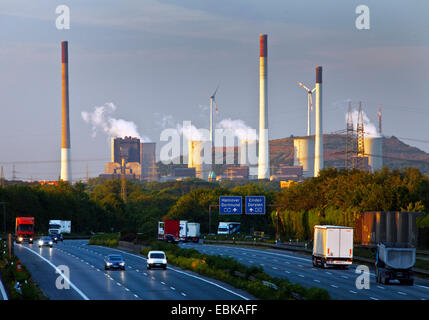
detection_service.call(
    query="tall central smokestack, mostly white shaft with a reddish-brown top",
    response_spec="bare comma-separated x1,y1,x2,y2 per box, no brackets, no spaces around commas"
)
258,34,270,179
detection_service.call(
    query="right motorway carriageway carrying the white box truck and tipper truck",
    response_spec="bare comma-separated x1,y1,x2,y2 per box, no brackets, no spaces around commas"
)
181,243,429,300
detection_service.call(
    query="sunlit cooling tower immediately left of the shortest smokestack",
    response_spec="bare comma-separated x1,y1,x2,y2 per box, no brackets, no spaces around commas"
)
293,136,314,178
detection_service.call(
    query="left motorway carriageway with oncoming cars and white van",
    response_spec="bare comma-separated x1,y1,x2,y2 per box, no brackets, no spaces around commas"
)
15,240,254,300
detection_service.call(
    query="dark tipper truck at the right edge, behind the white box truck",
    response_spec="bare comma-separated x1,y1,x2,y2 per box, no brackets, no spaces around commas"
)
375,243,416,286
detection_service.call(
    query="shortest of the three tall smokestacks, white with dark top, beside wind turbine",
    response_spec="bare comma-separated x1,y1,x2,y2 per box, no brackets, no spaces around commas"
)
314,66,324,177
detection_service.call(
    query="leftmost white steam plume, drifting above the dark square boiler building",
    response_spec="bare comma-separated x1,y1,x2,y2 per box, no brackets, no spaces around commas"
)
81,102,150,142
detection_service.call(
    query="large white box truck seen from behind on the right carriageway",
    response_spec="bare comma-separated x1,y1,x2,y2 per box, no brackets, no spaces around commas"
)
313,226,353,268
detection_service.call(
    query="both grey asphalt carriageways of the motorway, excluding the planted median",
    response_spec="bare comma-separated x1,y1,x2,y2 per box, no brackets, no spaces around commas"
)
10,240,429,300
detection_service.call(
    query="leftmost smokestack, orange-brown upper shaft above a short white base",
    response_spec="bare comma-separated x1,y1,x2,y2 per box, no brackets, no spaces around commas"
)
60,41,72,182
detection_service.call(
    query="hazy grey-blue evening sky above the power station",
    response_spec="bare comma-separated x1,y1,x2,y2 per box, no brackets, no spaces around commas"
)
0,0,429,180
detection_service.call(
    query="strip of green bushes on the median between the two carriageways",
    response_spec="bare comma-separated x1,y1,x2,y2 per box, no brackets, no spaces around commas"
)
141,241,330,300
